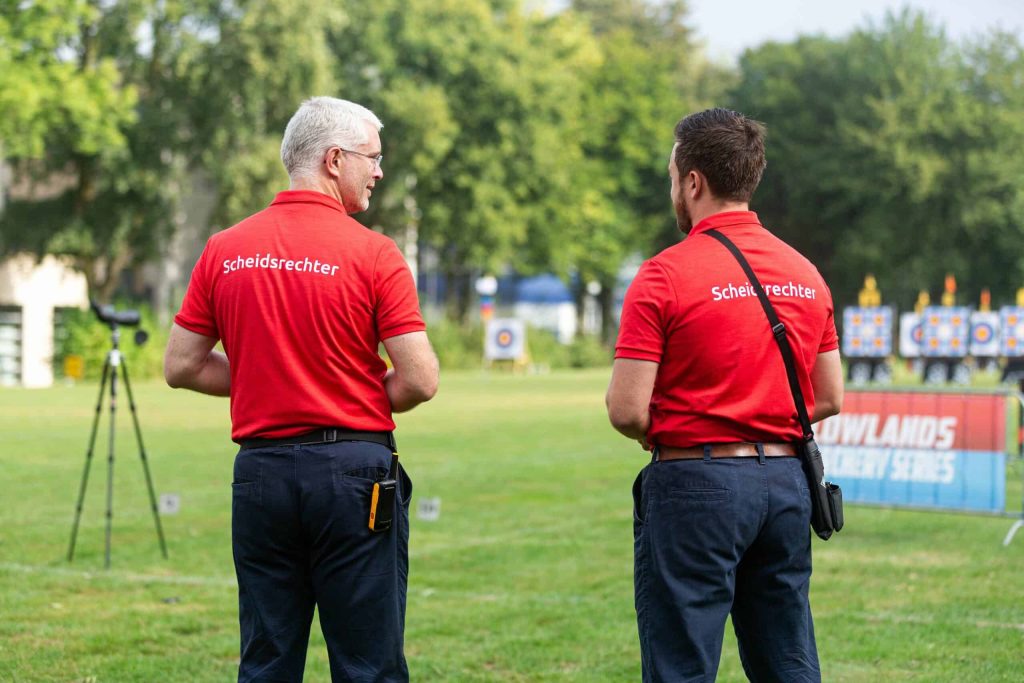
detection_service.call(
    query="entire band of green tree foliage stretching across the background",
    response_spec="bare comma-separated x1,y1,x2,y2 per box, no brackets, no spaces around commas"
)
0,0,1024,321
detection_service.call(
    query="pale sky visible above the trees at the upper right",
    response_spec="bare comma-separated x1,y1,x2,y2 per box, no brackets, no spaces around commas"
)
688,0,1024,60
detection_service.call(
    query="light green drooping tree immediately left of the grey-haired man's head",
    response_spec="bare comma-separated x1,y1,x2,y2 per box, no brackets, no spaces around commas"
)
187,0,346,227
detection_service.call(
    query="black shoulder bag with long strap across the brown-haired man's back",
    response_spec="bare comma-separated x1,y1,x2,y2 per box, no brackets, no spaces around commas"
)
708,229,843,541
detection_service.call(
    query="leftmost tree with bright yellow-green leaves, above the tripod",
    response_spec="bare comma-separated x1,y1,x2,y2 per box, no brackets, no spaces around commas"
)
2,1,190,299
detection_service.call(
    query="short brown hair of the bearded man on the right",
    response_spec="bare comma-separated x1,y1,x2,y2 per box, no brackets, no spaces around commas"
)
675,109,767,202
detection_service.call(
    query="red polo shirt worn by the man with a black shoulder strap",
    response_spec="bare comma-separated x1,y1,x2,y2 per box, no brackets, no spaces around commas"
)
615,211,839,447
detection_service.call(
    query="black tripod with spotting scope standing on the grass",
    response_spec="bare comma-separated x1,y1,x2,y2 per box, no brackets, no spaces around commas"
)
68,304,167,569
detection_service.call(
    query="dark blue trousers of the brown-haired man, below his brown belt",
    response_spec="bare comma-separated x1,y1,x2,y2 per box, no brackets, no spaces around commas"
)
633,458,821,683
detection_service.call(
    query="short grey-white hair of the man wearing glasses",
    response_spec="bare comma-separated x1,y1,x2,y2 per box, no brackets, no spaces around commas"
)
281,97,384,180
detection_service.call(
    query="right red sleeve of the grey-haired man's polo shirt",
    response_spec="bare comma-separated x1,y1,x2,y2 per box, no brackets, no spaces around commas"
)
374,240,427,339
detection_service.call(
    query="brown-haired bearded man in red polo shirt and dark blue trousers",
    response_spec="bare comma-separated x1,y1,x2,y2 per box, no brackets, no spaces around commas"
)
607,109,843,682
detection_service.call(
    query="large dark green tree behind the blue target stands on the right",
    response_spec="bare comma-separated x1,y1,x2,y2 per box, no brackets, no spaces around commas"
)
732,11,1024,307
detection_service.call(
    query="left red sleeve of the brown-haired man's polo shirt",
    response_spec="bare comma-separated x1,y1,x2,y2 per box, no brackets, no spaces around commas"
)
615,261,675,362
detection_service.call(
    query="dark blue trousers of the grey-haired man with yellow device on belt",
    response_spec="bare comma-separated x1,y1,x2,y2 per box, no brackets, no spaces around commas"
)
231,441,413,683
